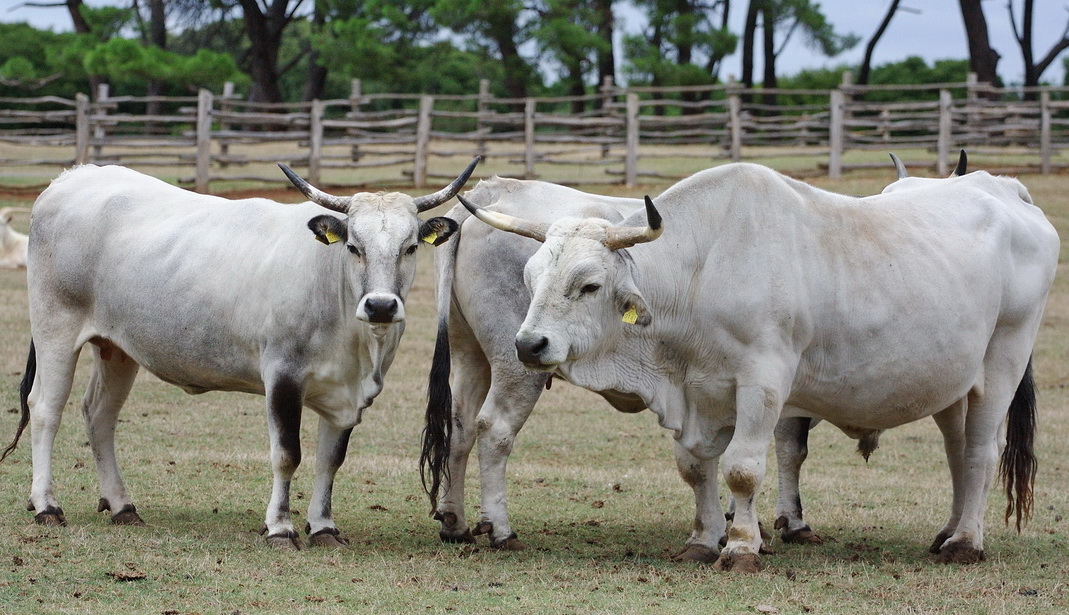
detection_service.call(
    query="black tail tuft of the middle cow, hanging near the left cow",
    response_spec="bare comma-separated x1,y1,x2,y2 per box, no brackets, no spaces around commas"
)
419,317,453,514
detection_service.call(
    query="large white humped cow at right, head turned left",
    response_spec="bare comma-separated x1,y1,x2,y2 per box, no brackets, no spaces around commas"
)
451,164,1059,571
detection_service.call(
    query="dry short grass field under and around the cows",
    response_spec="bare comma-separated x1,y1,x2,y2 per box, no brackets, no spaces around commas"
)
0,154,1069,615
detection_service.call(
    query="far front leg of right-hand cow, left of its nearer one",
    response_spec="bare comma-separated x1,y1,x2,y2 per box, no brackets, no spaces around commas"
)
672,442,727,564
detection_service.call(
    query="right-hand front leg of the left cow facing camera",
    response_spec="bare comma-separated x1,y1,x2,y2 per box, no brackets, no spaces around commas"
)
305,417,353,547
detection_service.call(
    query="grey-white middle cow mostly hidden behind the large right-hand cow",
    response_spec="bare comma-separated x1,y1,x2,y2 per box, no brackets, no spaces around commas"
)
428,178,838,560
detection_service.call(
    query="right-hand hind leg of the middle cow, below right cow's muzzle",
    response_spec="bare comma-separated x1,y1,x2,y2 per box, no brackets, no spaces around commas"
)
475,374,546,551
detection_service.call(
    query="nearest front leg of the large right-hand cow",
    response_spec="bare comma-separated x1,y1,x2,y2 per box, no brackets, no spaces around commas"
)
715,385,784,572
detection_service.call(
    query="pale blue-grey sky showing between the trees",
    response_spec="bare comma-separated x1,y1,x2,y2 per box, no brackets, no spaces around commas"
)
0,0,1069,84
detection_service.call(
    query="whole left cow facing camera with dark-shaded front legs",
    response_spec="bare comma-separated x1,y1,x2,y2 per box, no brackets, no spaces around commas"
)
3,158,479,549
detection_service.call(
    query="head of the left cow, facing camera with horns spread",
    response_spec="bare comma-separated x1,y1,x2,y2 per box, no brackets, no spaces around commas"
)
279,156,482,325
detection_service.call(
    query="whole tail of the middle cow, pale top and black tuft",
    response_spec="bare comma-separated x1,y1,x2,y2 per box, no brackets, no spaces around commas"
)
419,229,460,514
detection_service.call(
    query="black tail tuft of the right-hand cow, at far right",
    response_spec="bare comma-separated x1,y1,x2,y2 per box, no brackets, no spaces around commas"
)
998,357,1038,533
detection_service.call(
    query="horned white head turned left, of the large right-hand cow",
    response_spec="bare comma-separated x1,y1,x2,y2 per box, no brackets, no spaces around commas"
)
458,196,662,371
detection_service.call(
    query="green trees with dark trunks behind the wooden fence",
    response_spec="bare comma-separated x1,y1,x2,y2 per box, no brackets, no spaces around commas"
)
0,0,1069,102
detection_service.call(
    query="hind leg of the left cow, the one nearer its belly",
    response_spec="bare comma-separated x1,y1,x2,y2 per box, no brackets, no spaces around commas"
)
82,342,144,525
